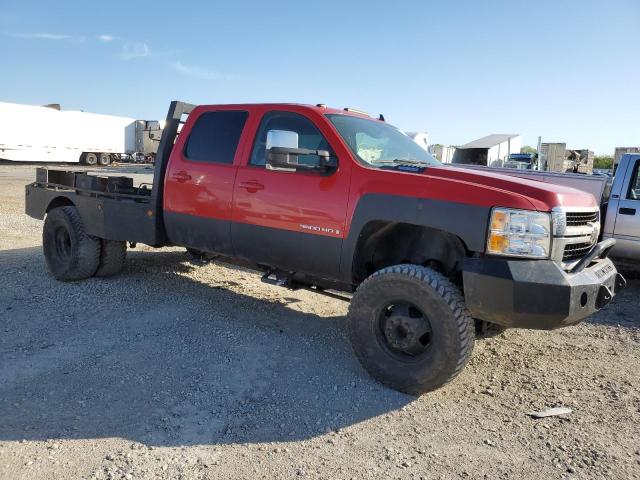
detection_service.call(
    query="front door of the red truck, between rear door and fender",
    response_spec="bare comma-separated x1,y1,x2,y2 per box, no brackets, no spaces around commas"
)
232,111,351,277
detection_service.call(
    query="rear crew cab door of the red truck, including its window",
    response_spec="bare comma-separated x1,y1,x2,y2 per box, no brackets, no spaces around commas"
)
163,107,248,255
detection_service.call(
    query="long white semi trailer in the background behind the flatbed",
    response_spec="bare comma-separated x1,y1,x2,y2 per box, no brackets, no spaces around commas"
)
0,102,162,166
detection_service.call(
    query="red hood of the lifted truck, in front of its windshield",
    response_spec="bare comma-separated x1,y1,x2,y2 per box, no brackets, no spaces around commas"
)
425,166,598,211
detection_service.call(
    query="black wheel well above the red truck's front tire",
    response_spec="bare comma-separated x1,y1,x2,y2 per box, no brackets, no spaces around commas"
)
353,221,467,284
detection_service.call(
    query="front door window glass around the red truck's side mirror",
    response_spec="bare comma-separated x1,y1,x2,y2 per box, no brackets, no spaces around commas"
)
249,112,333,166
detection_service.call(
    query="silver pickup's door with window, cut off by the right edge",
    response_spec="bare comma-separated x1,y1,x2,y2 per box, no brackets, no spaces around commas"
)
605,155,640,260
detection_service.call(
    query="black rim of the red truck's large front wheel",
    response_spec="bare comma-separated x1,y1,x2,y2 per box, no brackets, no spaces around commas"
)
378,301,433,361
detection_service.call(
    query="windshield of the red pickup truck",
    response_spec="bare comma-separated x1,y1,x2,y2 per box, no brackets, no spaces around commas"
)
327,114,440,167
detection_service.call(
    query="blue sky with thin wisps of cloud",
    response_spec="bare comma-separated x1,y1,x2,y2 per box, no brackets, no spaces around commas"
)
0,0,640,154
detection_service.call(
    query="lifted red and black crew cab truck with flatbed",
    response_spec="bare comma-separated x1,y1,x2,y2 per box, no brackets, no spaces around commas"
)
26,102,625,394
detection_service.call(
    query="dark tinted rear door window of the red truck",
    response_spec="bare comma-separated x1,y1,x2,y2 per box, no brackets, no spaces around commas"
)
184,110,248,164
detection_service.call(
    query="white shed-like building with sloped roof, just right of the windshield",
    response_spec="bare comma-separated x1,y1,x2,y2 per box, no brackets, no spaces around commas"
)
453,133,522,167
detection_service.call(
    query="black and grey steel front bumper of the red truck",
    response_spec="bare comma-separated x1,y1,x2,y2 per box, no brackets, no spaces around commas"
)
463,241,626,330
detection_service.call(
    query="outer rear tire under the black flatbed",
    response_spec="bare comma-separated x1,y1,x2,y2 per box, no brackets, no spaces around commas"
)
42,206,100,282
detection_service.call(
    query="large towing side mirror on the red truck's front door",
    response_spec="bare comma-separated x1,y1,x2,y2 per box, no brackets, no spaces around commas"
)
266,130,338,172
